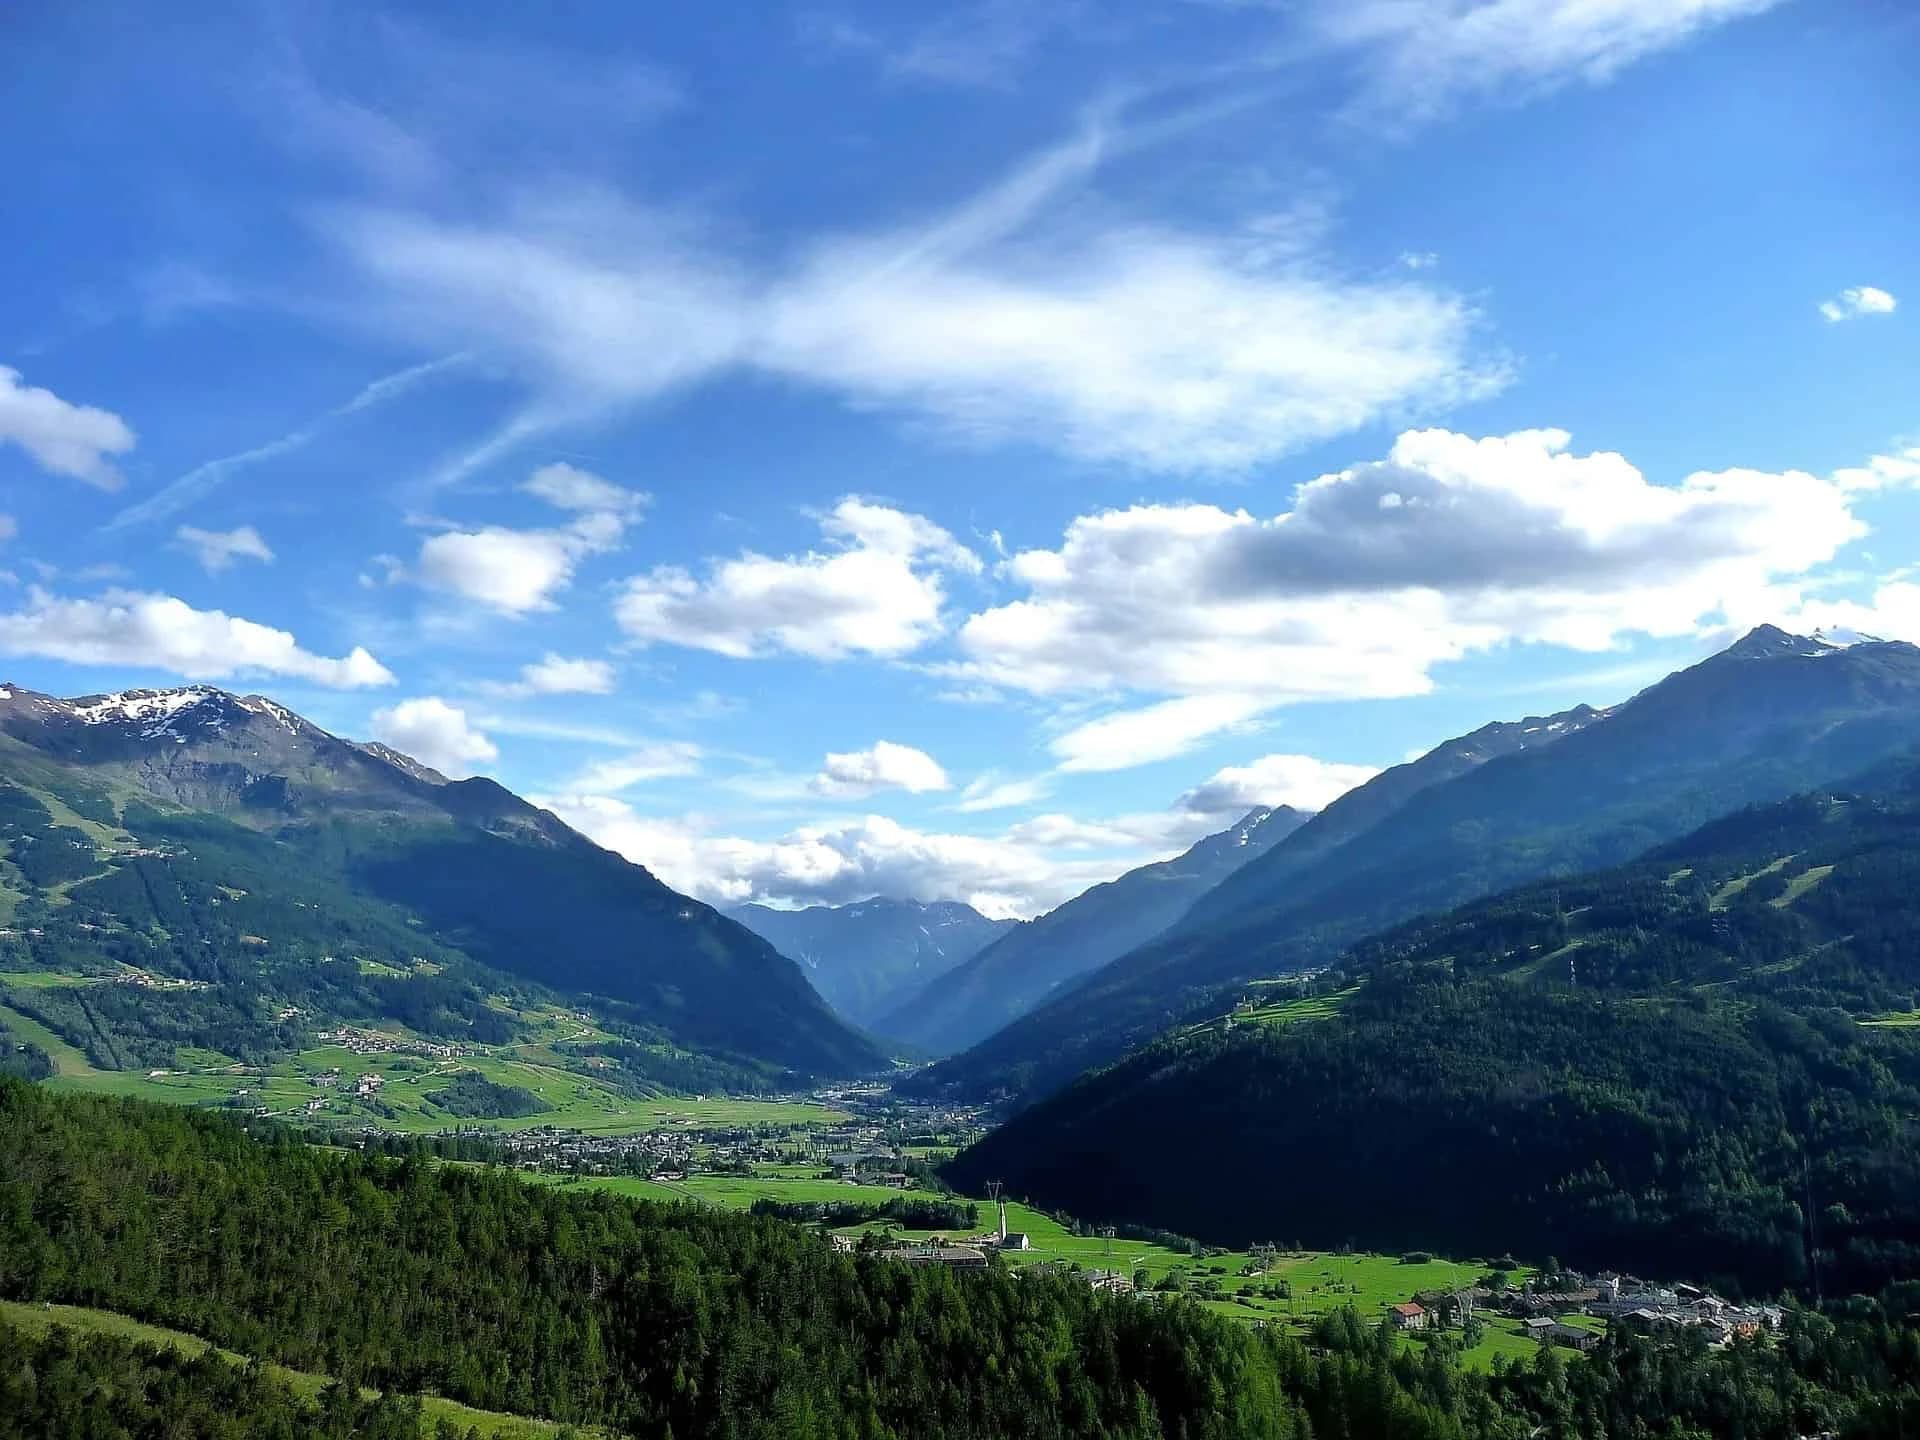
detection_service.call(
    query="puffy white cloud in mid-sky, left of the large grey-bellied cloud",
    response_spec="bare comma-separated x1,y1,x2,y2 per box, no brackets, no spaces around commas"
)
614,497,981,660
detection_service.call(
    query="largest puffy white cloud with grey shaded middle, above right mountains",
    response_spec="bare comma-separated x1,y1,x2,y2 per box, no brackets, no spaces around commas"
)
950,430,1864,733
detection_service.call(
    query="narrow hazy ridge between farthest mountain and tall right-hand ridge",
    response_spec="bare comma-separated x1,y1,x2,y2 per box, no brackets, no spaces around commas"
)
874,804,1308,1054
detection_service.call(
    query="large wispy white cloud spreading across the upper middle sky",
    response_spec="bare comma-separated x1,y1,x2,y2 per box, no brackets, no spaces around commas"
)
328,125,1507,470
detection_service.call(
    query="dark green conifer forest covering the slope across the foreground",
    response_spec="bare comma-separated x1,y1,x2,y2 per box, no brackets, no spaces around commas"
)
18,1077,1920,1440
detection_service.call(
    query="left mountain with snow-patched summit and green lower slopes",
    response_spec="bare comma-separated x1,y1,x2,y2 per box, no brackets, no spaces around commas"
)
0,685,883,1073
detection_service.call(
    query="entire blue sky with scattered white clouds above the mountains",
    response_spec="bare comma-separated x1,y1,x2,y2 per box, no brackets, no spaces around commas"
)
0,0,1920,916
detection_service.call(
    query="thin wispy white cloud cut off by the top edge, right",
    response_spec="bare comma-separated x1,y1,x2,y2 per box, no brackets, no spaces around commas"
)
1309,0,1778,127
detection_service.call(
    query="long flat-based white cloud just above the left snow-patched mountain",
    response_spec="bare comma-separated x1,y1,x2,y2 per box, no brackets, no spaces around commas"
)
0,588,394,689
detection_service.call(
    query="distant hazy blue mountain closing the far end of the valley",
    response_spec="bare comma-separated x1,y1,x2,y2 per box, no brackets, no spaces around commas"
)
728,899,1020,1033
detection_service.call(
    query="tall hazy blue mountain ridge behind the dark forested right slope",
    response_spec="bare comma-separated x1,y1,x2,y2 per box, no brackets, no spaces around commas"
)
916,626,1920,1098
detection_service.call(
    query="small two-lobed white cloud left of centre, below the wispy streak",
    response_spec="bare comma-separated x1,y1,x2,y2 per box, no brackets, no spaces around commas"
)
417,465,647,614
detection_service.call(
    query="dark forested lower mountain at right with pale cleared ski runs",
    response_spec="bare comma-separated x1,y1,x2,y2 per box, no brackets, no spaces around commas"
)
950,760,1920,1292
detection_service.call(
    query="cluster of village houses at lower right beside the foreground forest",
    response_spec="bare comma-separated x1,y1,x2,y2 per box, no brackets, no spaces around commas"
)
1386,1273,1782,1350
